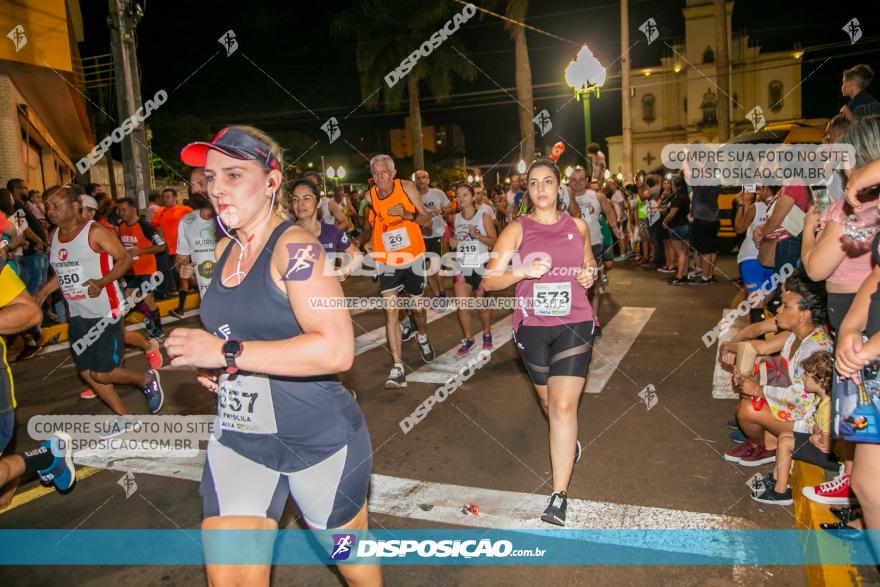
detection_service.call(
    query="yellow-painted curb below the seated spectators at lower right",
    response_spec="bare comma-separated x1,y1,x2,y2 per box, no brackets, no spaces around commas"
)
791,461,862,587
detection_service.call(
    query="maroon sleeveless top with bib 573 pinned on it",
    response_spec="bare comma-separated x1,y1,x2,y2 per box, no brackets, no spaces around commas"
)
513,214,593,330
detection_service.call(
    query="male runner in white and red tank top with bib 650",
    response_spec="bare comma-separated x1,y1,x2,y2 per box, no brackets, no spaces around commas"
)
36,184,165,424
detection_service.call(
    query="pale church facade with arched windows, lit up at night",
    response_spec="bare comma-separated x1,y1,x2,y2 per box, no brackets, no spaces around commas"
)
607,0,803,175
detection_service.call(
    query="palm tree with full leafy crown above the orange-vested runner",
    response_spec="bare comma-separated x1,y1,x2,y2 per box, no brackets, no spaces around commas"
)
331,0,475,169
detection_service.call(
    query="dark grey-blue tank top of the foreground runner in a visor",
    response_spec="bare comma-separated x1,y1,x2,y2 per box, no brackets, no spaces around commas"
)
201,221,365,473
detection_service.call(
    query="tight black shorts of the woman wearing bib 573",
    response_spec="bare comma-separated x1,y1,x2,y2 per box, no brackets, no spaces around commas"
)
513,321,593,385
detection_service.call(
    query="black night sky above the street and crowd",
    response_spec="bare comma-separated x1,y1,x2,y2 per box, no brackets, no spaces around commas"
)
81,0,880,178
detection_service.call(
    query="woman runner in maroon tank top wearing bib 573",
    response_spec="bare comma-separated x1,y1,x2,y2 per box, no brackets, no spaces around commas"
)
483,159,596,526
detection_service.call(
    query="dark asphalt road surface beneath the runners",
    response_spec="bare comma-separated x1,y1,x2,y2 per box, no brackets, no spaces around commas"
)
0,258,844,586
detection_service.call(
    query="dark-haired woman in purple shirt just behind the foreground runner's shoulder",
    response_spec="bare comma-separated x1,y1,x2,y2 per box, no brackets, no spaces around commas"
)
290,179,361,281
